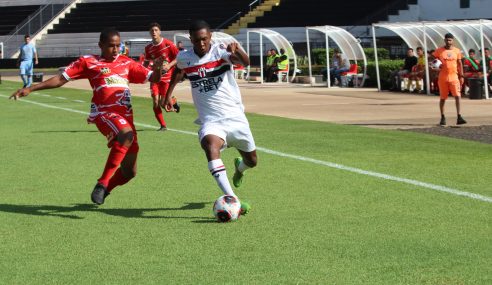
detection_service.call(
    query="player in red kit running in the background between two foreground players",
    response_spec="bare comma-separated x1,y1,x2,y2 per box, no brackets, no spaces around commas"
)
144,22,179,131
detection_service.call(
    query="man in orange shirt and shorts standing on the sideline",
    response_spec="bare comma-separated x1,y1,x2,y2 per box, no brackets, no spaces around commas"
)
433,33,466,126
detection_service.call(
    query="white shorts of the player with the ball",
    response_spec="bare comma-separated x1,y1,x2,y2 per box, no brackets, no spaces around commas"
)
198,116,256,152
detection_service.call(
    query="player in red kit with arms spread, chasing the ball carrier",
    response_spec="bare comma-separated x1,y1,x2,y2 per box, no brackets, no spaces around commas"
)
10,28,162,205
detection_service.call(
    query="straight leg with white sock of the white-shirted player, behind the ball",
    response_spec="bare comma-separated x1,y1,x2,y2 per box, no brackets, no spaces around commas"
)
200,132,236,196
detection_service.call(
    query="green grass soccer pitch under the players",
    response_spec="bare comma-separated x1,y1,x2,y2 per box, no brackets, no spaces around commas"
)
0,81,492,284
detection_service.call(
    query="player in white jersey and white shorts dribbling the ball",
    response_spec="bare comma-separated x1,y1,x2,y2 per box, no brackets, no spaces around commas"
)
161,20,257,202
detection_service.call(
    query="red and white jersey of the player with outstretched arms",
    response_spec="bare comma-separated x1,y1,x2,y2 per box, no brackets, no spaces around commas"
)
62,55,152,122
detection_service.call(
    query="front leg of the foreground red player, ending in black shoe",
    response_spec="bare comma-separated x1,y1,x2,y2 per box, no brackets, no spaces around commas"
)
91,114,135,205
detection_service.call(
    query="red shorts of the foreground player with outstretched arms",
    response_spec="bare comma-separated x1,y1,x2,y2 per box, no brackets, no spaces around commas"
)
93,113,139,153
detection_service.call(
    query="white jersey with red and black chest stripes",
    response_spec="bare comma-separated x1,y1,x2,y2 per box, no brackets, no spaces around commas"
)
177,44,244,124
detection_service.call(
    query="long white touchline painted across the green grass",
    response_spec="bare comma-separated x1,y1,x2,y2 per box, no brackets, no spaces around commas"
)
0,94,492,203
